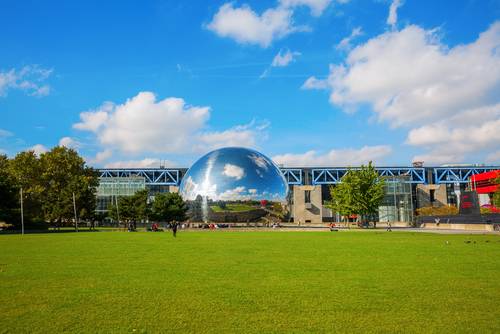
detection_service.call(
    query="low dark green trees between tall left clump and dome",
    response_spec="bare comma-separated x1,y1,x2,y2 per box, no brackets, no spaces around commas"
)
108,189,188,222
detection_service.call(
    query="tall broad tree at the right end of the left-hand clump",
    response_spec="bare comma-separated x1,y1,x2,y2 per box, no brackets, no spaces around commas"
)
40,146,99,230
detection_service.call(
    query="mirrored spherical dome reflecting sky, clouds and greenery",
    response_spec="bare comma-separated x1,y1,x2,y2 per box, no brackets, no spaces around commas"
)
179,147,288,221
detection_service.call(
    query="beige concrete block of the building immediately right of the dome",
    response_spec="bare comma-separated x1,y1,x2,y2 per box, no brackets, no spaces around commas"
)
293,185,323,225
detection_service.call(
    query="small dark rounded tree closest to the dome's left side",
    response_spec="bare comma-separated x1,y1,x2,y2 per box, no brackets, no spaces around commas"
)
152,193,187,222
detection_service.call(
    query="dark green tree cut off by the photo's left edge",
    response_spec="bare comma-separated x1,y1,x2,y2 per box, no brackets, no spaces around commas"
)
0,155,19,223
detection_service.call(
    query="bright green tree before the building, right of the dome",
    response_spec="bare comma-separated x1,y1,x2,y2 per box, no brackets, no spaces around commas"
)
326,162,385,221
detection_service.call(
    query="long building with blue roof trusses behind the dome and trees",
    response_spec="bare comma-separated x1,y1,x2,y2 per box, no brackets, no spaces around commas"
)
97,166,500,224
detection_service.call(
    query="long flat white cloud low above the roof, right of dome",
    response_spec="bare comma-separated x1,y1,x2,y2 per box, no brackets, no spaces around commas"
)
273,145,392,167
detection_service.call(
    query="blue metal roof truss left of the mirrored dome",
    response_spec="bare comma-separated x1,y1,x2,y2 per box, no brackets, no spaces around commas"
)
99,168,180,186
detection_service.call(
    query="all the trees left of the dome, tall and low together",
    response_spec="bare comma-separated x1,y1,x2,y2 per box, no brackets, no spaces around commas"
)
0,147,187,228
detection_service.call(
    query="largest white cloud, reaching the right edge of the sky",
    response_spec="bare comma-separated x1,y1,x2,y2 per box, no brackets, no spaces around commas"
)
306,22,500,126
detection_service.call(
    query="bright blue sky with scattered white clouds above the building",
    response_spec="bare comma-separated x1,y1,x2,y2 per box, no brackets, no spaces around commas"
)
0,0,500,167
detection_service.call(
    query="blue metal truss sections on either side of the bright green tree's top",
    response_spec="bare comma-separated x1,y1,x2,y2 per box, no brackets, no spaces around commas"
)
311,167,426,185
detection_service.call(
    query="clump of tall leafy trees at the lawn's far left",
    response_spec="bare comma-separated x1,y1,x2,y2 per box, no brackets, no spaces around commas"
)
0,146,99,226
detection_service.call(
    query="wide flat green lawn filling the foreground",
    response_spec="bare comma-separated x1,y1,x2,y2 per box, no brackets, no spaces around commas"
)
0,231,500,333
